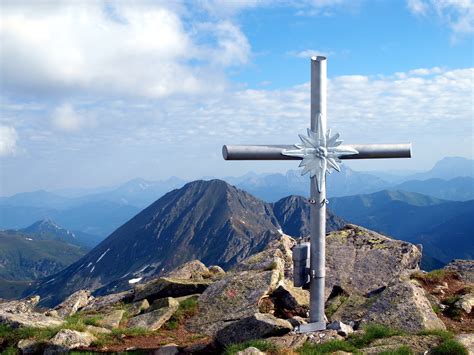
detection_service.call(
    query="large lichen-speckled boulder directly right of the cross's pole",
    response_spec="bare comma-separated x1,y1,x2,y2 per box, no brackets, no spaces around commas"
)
326,224,421,296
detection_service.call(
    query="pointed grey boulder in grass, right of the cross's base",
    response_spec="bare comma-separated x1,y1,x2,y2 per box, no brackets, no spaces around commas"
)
361,281,446,333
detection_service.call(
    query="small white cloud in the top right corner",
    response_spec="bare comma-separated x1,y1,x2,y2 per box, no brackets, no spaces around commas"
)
407,0,474,35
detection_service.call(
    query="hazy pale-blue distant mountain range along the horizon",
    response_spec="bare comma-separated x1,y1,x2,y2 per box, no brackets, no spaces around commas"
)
0,157,474,245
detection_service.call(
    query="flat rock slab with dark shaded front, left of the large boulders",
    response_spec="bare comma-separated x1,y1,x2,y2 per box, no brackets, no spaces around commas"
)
133,277,212,302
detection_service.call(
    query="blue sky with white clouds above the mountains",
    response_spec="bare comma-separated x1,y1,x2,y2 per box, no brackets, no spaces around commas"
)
0,0,474,195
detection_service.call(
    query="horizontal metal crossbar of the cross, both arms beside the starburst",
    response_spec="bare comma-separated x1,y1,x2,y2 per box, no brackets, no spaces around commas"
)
222,143,411,160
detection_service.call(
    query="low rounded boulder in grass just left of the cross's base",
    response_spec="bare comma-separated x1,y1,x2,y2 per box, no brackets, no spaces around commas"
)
215,313,293,346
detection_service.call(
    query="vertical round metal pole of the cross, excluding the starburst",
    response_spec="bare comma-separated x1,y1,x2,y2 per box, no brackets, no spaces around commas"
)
310,57,327,331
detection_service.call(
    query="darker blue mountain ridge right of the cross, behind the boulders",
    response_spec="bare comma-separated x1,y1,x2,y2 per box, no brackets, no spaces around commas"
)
329,190,474,264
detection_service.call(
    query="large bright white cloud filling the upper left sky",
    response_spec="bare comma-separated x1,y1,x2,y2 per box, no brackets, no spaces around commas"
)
0,1,250,98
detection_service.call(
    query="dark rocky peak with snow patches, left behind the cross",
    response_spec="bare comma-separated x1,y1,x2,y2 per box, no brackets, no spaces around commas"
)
24,180,344,306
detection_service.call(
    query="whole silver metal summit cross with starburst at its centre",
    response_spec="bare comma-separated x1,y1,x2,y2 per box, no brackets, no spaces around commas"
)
222,57,411,332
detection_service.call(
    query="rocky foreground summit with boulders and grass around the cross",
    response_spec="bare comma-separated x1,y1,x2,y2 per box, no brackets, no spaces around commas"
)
0,225,474,354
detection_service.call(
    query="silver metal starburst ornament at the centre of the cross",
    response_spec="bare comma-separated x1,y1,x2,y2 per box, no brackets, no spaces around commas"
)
282,117,359,192
